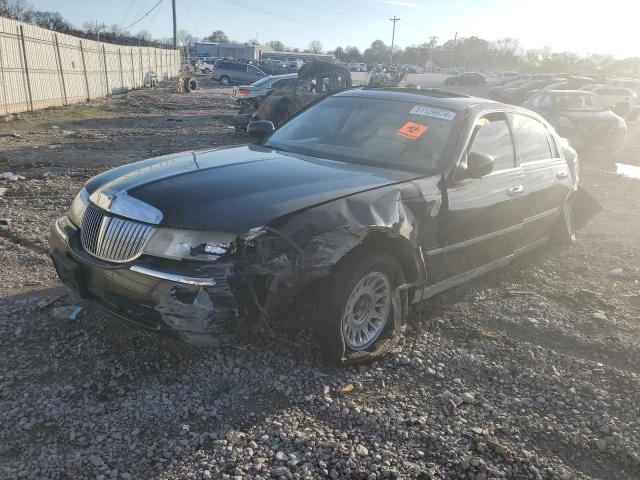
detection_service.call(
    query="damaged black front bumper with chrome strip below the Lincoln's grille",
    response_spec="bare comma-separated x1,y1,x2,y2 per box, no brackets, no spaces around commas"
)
51,217,242,346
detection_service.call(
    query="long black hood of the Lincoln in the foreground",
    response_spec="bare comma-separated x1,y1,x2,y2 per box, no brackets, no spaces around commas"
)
86,145,419,234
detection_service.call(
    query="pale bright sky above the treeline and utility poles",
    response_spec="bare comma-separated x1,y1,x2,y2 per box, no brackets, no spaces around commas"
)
27,0,640,58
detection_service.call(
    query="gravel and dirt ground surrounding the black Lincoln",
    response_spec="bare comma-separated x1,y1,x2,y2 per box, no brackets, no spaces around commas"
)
0,80,640,480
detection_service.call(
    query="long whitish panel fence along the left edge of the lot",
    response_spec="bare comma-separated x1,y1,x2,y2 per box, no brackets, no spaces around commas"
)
0,17,180,115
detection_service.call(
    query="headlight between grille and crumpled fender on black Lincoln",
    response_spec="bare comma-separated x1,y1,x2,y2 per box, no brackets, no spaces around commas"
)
144,228,237,261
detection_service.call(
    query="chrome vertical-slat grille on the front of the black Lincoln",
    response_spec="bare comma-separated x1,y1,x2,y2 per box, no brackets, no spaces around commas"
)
80,203,154,263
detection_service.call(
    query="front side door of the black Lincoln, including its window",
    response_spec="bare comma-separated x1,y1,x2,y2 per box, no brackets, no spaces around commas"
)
431,112,525,282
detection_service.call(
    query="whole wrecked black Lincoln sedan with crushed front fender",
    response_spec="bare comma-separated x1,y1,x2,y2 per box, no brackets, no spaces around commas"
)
51,87,596,363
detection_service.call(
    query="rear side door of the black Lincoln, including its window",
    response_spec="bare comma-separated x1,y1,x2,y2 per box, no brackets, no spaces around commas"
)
510,113,572,250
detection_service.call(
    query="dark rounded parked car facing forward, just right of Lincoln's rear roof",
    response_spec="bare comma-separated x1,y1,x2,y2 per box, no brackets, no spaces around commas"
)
522,90,627,149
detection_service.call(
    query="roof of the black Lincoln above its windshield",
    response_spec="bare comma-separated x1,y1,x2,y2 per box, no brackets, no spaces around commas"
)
334,87,502,111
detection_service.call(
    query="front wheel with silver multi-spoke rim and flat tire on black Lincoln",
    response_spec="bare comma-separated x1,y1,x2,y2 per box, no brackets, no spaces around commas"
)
313,248,408,365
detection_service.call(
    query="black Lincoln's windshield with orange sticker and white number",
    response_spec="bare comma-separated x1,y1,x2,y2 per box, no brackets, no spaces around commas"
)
265,96,455,171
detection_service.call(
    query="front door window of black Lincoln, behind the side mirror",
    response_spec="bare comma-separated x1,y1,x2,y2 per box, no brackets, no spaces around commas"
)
469,115,516,171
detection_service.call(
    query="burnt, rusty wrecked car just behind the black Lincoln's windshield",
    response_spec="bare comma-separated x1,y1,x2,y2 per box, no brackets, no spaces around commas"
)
231,61,351,128
